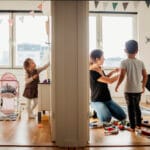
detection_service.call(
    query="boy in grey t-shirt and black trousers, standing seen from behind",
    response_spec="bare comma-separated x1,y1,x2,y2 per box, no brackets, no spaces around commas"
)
115,40,147,131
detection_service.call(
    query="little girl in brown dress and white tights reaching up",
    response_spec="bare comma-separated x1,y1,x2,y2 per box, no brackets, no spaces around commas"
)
23,58,49,118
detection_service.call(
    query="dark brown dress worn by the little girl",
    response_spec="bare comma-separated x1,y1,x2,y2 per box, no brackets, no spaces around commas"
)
23,69,39,99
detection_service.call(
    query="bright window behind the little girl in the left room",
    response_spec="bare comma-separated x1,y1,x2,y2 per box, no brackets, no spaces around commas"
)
0,13,49,68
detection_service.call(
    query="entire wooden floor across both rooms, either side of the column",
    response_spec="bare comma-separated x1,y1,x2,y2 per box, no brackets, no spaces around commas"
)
0,102,150,150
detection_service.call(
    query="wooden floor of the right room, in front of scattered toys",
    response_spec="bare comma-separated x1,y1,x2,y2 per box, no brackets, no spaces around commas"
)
89,103,150,150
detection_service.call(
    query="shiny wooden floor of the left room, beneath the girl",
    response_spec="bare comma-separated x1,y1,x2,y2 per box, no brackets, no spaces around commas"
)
0,111,53,146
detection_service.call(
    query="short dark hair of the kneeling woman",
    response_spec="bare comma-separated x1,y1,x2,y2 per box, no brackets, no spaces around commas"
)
90,49,103,64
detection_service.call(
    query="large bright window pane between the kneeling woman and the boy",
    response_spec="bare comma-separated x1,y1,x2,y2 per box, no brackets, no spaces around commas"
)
90,14,136,69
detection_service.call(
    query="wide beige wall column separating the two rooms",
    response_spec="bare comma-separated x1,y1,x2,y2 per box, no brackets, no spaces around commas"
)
51,0,89,147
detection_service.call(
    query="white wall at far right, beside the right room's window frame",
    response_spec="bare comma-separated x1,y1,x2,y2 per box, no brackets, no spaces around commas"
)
138,1,150,98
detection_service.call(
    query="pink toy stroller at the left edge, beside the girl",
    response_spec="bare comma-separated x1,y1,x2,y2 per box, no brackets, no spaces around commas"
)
0,73,20,120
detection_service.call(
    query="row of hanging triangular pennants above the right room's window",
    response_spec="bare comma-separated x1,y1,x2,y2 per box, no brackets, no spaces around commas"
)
94,0,150,11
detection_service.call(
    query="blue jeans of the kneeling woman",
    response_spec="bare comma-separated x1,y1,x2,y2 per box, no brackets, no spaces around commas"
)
91,100,126,122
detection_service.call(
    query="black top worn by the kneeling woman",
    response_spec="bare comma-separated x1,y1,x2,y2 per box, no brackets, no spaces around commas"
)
90,70,112,102
